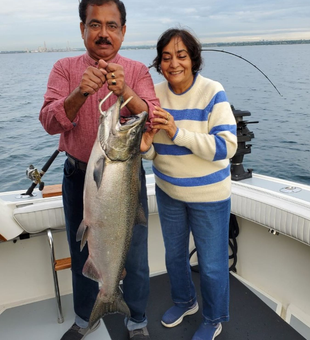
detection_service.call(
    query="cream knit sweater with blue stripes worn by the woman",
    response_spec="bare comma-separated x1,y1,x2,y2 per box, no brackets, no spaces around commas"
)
143,74,237,202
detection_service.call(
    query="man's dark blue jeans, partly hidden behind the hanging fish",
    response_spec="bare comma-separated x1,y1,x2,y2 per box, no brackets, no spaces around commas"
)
62,160,149,329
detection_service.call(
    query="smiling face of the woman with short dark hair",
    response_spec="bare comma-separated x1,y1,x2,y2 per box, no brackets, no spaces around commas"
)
160,37,194,94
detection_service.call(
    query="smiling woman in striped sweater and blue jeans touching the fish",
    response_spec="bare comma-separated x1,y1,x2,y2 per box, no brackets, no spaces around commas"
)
141,29,237,340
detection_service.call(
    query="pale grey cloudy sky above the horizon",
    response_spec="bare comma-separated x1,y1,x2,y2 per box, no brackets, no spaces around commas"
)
0,0,310,51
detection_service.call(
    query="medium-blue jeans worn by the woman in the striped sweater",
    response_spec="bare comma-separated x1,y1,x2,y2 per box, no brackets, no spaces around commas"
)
156,186,230,323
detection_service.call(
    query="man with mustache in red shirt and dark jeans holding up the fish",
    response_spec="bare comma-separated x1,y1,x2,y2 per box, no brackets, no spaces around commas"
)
39,0,159,340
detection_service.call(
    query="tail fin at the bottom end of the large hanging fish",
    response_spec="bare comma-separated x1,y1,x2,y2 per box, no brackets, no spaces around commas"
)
88,290,130,327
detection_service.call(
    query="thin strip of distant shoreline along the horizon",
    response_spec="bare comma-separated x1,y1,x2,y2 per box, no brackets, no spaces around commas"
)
0,39,310,54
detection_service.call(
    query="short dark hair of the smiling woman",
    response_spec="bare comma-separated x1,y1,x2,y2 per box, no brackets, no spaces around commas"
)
152,28,202,74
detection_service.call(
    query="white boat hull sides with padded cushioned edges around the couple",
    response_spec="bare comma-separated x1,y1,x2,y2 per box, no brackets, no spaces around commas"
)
0,174,310,338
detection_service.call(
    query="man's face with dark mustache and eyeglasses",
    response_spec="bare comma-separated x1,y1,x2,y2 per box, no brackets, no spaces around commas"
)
80,2,126,61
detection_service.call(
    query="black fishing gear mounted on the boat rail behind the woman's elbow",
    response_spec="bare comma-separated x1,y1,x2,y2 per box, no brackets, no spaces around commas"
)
230,105,258,181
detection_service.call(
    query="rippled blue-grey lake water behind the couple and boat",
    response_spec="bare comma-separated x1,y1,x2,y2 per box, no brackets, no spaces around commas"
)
0,44,310,192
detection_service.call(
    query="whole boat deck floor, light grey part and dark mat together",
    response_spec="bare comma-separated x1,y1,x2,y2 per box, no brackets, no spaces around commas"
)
0,272,305,340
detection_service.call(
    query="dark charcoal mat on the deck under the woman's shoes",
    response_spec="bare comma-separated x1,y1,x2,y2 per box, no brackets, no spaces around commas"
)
104,272,305,340
